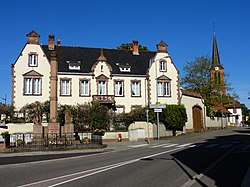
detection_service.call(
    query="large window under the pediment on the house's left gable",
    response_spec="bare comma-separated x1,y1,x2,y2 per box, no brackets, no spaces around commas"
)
24,77,41,95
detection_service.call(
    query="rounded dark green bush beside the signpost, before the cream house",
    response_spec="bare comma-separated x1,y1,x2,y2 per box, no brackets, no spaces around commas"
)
163,105,187,136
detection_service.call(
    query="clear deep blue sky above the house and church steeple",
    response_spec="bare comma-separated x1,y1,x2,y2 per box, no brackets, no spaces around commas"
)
0,0,250,108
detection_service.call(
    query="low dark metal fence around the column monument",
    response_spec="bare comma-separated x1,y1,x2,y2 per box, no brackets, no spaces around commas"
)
5,132,102,148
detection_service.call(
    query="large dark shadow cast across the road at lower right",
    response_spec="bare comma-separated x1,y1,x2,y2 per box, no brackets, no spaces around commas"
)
171,132,250,187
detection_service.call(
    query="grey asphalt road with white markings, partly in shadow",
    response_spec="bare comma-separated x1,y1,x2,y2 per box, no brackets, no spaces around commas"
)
0,128,250,187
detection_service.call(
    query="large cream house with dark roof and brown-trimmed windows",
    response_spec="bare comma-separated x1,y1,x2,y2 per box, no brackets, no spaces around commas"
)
11,31,180,112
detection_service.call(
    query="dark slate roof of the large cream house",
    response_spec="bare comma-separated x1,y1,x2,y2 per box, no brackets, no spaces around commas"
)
42,45,156,75
